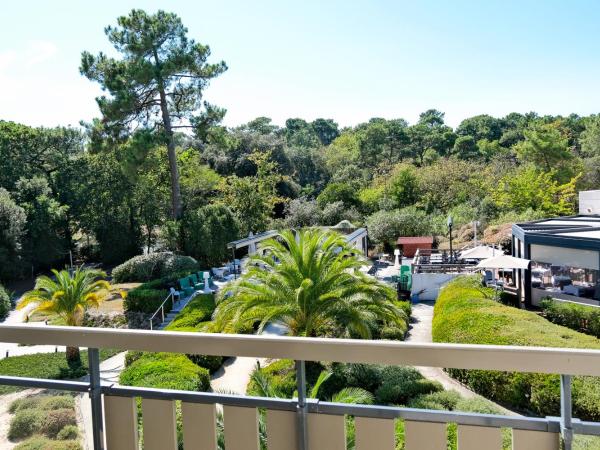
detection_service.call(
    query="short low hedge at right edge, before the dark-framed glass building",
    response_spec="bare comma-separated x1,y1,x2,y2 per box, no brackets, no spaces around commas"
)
540,299,600,338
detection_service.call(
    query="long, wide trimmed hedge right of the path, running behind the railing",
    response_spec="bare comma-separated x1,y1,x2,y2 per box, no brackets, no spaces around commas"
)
432,277,600,421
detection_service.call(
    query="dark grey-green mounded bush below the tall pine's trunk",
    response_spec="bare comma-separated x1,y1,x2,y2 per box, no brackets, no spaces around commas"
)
112,252,199,283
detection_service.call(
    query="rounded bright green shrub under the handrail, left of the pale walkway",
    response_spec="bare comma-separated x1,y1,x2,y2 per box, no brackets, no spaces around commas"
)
119,353,210,391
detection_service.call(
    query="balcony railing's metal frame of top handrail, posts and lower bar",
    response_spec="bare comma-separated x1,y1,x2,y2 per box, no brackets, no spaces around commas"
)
0,325,600,450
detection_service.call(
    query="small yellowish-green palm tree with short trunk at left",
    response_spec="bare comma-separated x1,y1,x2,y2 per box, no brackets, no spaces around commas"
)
17,267,110,366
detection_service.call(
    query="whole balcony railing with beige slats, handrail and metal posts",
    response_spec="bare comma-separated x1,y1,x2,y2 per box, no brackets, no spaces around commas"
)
0,326,600,450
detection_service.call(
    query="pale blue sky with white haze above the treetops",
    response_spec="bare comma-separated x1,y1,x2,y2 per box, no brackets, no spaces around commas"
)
0,0,600,126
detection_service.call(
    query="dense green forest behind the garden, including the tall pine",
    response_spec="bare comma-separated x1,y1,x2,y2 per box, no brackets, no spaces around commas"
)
0,10,600,280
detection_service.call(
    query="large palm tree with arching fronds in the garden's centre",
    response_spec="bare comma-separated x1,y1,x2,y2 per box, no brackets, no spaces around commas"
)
212,229,406,338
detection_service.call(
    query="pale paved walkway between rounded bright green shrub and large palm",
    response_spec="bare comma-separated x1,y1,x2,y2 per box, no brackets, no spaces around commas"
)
210,323,286,394
